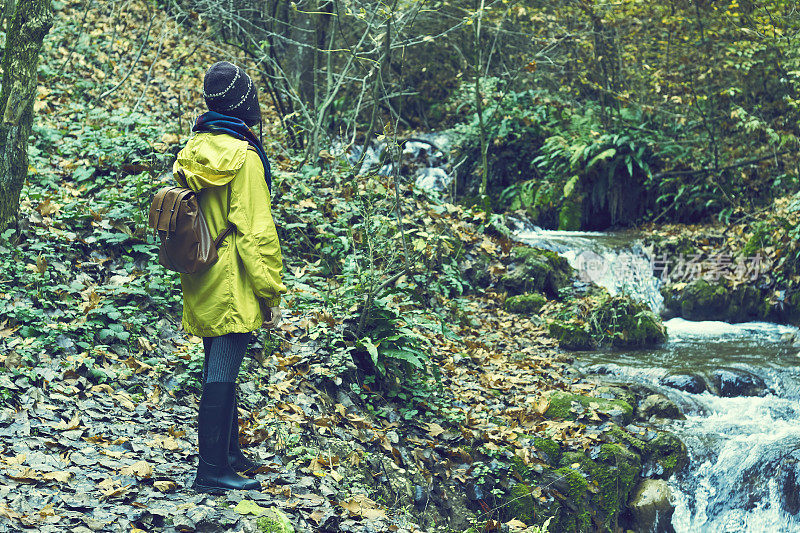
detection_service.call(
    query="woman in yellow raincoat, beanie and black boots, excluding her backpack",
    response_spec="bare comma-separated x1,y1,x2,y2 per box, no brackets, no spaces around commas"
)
173,62,286,493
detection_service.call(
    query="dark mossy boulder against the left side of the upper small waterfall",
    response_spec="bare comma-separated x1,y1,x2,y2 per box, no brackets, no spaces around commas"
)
500,246,572,298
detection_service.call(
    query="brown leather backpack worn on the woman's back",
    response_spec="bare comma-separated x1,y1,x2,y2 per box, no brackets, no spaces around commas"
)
150,170,236,274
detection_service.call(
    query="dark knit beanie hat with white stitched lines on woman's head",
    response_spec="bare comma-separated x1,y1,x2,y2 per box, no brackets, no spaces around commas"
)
203,61,261,127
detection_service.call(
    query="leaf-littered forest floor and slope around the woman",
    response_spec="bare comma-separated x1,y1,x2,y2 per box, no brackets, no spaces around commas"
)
0,0,780,532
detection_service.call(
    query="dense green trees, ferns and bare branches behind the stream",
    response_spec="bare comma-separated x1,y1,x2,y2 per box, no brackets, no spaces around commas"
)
161,0,798,229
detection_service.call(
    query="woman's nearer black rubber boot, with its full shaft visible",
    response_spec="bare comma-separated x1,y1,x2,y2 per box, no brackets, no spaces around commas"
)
193,383,261,494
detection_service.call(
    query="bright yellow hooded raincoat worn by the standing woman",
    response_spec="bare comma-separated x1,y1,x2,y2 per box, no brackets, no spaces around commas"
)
172,133,286,337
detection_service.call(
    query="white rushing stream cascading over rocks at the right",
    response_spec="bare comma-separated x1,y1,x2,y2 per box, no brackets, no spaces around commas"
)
511,220,800,533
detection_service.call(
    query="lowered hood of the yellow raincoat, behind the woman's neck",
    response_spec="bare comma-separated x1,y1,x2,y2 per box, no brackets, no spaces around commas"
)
173,133,248,191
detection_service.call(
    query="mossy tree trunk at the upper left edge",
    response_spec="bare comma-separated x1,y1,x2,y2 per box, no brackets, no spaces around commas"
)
0,0,53,231
